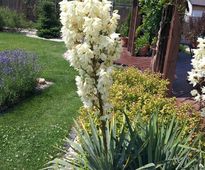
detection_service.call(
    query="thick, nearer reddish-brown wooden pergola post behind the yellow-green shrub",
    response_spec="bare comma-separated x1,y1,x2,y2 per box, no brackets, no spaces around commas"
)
152,4,182,95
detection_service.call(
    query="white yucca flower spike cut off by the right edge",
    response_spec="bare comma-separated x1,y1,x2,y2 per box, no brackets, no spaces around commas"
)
188,38,205,116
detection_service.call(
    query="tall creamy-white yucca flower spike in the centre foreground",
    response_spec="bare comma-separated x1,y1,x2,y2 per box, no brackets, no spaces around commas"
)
60,0,121,112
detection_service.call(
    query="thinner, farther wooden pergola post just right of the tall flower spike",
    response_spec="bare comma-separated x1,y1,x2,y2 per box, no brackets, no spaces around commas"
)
127,0,138,55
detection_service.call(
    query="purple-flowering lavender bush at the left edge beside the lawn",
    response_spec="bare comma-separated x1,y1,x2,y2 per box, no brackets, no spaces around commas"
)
0,50,38,111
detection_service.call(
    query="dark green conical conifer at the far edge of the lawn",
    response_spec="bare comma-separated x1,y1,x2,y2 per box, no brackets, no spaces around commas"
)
37,1,60,38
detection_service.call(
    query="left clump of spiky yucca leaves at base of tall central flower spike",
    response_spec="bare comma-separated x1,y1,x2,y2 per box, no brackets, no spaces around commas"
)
49,118,129,170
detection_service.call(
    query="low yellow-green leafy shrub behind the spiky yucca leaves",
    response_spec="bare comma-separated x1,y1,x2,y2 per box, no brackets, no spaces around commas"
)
80,68,200,136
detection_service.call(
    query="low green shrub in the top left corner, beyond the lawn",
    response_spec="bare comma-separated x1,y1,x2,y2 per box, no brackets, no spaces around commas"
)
0,7,31,29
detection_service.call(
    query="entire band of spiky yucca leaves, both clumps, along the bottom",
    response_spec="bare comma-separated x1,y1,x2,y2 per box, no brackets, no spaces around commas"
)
49,112,204,170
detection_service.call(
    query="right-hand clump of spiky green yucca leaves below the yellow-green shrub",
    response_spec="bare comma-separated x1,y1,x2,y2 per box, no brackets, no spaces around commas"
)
125,114,204,170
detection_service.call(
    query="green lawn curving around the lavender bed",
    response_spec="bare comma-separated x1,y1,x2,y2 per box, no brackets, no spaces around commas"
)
0,33,81,170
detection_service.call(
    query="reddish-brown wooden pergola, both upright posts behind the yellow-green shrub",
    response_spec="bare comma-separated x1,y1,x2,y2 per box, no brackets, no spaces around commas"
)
127,0,186,92
